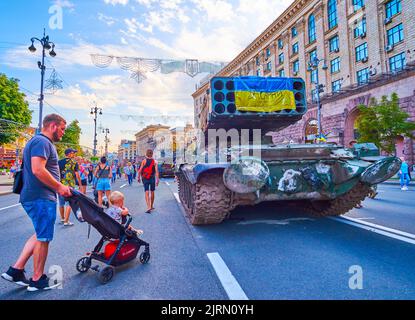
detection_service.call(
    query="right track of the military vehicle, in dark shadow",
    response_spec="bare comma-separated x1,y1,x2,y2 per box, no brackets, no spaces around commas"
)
306,183,370,217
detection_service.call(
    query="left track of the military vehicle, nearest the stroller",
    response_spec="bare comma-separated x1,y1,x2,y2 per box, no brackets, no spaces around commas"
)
177,170,233,225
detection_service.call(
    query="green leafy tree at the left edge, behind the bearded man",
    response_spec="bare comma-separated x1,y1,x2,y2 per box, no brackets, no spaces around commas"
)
0,74,32,144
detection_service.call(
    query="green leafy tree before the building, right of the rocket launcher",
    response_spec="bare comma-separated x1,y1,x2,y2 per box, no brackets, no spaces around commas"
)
356,93,415,154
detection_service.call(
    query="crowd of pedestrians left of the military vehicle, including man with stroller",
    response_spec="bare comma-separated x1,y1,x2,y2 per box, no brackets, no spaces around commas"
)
1,114,159,291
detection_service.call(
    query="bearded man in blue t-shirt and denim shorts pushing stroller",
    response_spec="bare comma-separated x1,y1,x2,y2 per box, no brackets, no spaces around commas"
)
1,114,71,291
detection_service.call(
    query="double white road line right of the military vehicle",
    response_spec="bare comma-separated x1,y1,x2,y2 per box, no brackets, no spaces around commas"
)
329,217,415,244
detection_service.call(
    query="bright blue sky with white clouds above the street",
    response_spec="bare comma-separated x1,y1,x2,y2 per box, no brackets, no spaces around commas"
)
0,0,292,150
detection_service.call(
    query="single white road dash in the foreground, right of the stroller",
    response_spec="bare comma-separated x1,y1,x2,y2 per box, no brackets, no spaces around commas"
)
207,252,249,300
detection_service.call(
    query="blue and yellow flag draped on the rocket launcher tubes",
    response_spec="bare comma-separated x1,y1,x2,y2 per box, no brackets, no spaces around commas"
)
234,77,296,112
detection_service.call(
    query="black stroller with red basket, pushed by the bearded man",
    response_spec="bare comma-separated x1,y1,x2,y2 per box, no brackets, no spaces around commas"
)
67,190,150,284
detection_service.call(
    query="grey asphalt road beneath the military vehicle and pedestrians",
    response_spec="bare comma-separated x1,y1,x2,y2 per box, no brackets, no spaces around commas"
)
0,179,415,300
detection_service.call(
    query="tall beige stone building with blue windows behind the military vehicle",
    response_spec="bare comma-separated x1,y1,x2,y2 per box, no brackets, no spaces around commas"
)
193,0,415,163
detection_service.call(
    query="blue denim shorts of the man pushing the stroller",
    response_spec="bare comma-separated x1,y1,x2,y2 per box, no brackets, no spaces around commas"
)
22,199,56,242
